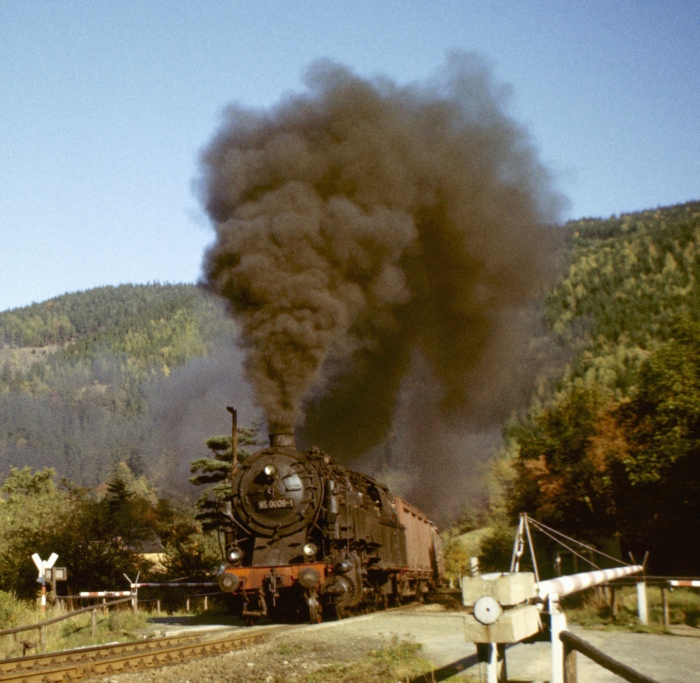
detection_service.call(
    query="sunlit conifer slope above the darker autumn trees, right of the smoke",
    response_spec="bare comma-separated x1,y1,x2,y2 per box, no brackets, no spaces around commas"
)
547,203,700,384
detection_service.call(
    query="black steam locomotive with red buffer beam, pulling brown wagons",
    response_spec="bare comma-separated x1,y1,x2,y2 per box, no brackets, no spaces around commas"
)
218,434,444,624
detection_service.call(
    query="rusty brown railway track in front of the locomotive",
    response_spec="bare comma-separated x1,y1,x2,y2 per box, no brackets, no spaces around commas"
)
0,626,289,683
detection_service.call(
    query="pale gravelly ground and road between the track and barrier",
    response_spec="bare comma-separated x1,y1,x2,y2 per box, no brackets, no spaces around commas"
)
87,606,700,683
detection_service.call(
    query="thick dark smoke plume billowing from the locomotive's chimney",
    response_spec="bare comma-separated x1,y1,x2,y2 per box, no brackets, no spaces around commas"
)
201,54,560,520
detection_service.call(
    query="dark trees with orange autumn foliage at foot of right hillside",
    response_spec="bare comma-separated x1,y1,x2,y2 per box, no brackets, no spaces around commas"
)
510,321,700,575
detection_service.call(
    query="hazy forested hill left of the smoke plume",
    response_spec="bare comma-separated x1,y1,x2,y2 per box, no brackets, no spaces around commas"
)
0,285,239,485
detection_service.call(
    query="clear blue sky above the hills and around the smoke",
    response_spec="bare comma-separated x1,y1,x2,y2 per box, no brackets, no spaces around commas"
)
0,0,700,310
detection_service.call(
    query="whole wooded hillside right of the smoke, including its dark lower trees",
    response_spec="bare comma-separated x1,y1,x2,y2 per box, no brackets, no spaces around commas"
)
507,202,700,574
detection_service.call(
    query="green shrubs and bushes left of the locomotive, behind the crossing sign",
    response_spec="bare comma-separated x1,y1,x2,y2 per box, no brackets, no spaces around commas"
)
0,463,221,605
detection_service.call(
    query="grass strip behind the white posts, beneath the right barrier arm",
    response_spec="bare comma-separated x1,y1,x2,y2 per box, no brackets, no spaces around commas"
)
562,586,700,633
